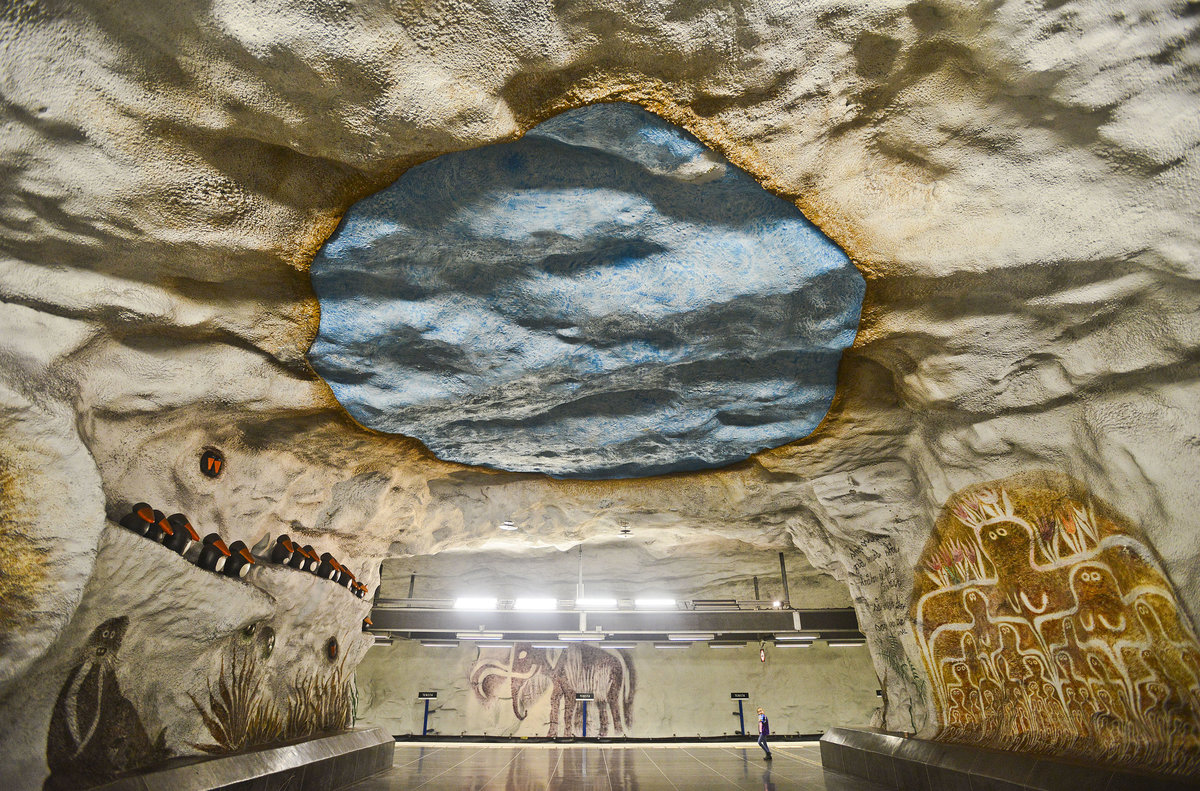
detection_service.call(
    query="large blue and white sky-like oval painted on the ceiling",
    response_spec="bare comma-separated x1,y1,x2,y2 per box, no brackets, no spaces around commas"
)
308,103,864,478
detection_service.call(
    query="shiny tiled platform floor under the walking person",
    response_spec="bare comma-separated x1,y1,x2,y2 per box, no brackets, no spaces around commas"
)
346,742,897,791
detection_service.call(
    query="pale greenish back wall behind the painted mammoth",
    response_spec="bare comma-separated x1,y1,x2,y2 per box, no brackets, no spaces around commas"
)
356,641,878,738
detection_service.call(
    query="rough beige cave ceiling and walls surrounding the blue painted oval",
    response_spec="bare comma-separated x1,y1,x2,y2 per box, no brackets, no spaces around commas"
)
0,0,1200,789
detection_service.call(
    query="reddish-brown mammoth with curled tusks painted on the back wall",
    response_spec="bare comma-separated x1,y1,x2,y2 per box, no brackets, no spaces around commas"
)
470,642,637,738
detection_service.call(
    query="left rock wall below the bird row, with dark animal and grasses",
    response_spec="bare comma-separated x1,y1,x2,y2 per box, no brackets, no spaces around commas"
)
0,523,371,789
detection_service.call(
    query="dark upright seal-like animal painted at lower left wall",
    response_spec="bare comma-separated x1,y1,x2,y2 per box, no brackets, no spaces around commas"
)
42,616,169,791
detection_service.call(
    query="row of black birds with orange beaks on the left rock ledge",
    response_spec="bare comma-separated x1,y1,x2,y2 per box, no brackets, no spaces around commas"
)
121,503,367,599
